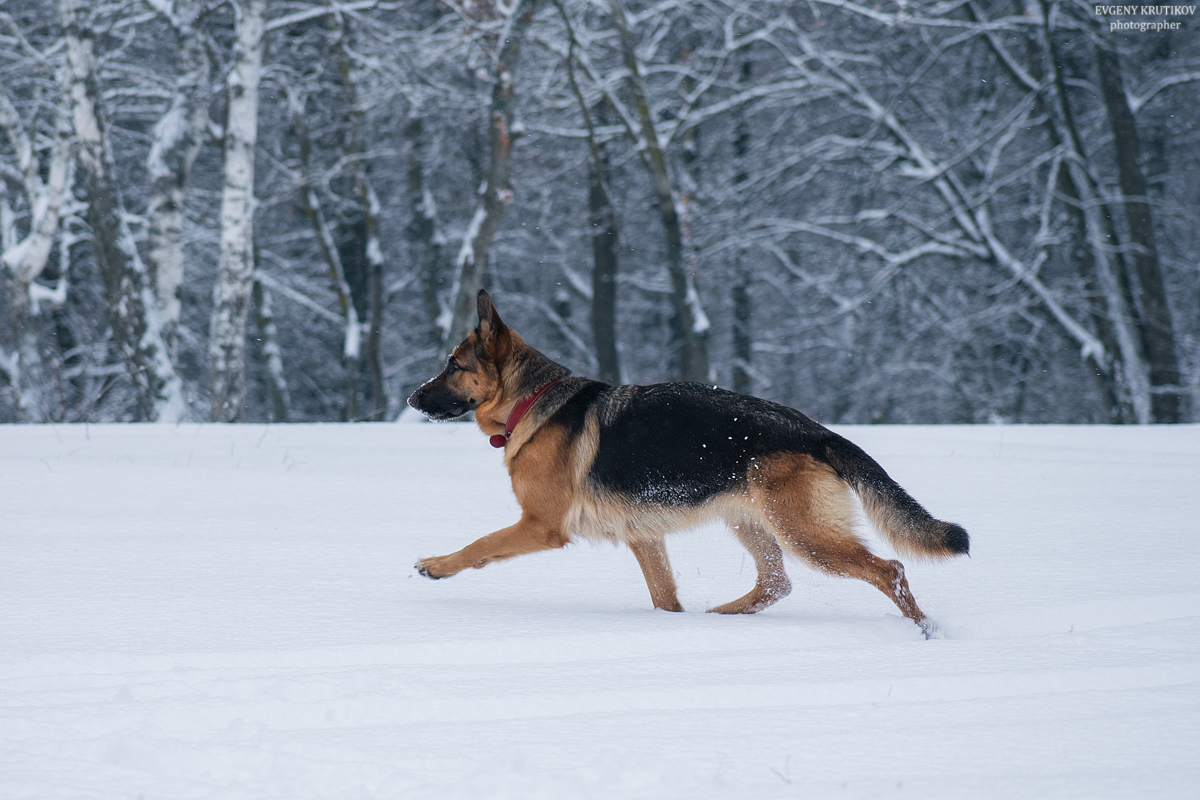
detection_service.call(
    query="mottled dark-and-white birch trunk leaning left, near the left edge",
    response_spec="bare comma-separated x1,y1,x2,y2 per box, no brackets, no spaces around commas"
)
62,0,187,422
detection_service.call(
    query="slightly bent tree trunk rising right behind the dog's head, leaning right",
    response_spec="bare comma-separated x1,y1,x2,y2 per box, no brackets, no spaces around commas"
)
442,0,538,353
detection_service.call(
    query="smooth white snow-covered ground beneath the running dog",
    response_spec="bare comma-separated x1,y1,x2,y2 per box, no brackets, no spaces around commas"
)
0,425,1200,800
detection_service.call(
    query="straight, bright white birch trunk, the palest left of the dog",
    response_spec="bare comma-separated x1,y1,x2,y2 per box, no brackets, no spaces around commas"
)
209,0,266,422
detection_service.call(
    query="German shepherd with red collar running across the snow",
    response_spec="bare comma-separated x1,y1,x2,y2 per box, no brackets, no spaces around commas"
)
408,291,968,636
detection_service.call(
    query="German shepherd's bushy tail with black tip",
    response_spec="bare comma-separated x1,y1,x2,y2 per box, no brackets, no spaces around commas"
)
826,437,971,558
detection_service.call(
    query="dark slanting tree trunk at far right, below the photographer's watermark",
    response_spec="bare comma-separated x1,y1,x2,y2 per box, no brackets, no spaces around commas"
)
1096,41,1187,422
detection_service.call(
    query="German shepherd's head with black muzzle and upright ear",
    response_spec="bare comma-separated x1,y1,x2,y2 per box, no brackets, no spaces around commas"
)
408,289,516,420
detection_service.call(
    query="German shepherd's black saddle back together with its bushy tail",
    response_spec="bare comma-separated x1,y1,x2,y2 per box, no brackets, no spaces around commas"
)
552,381,968,557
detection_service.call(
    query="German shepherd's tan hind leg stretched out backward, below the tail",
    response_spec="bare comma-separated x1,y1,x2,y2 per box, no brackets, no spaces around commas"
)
751,455,926,630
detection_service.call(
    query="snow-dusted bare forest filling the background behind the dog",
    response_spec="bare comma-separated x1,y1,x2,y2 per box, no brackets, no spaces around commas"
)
0,0,1200,423
